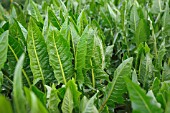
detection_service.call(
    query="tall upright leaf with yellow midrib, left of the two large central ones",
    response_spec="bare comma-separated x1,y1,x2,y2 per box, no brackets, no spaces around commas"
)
27,18,54,85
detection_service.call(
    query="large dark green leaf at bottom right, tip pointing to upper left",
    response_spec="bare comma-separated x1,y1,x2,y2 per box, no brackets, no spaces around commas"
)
125,78,162,113
